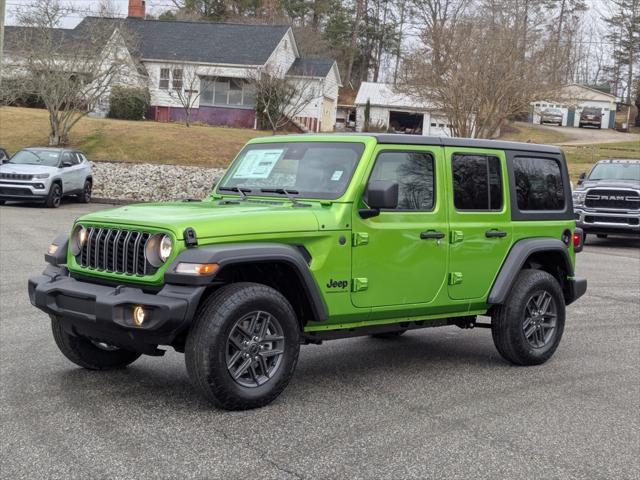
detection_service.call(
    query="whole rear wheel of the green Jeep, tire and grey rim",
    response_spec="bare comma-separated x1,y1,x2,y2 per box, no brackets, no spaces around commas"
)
491,270,565,365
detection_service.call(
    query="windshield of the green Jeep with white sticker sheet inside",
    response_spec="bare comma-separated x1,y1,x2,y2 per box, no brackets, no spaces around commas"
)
218,142,364,200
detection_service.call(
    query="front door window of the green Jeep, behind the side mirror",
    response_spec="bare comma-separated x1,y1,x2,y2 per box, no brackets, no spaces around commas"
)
369,151,435,211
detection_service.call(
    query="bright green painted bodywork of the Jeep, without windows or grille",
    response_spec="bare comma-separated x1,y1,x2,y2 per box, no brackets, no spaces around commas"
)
68,135,575,332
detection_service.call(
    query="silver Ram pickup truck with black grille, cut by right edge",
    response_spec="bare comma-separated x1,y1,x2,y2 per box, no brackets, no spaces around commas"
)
573,159,640,238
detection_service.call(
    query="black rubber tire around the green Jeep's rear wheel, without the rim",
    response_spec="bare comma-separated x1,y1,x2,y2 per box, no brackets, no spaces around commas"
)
491,269,565,366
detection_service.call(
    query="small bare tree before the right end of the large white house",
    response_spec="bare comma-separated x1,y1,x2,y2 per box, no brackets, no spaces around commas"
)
250,71,321,135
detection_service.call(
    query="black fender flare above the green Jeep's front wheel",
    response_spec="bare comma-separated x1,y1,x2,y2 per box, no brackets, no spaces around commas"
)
164,243,328,321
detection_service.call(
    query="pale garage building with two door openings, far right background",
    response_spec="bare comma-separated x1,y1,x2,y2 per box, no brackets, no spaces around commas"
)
529,84,617,128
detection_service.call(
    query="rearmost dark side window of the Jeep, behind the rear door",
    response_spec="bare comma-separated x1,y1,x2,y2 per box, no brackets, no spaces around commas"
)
513,157,565,210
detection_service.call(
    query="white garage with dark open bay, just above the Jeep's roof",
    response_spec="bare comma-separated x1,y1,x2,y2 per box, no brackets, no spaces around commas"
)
355,82,451,137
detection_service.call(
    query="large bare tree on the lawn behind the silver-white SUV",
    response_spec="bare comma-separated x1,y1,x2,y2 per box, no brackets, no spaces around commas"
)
2,0,138,145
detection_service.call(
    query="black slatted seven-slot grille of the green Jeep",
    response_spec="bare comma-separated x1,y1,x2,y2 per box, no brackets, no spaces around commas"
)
76,227,157,276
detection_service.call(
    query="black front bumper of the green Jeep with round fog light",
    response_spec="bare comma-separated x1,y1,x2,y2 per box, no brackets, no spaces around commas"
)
29,265,205,353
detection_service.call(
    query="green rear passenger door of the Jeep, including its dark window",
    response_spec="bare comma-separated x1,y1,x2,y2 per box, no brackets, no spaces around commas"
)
445,147,513,300
